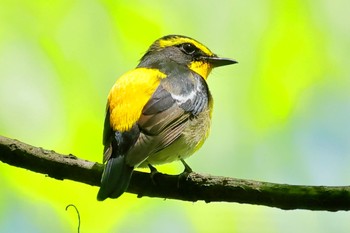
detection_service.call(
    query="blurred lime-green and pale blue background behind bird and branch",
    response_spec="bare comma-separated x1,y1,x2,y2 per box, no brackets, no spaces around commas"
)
0,0,350,232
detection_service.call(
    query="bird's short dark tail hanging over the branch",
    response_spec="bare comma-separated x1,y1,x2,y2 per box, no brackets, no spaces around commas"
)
97,156,134,201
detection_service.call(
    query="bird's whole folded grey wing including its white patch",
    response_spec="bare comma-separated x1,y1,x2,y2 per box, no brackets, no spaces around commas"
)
126,73,208,166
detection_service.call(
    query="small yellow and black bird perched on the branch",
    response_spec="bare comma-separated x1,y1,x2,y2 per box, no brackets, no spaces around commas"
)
97,35,237,201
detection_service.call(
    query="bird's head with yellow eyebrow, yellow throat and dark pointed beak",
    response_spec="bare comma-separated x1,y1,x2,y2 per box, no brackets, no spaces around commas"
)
139,35,237,79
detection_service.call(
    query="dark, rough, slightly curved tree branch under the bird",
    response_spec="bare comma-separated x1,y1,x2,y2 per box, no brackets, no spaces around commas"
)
0,136,350,211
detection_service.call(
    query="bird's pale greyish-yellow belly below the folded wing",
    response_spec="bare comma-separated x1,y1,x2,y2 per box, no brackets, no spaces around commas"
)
139,109,211,167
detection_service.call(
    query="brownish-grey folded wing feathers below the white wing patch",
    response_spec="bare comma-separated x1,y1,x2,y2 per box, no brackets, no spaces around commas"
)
126,86,190,166
